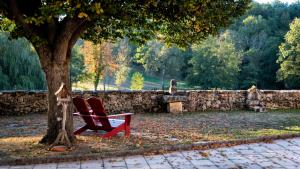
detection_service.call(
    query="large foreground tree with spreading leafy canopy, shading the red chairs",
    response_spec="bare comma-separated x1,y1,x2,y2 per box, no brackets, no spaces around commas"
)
0,0,251,143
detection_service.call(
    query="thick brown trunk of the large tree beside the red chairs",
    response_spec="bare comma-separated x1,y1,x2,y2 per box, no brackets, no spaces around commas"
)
39,48,75,144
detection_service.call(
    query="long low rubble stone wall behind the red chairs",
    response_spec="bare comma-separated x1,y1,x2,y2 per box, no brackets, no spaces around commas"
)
0,90,300,115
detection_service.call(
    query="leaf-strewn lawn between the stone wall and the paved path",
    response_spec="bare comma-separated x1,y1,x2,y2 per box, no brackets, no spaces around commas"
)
0,110,300,160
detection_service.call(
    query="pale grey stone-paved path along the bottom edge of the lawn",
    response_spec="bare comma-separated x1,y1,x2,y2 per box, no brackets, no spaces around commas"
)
0,138,300,169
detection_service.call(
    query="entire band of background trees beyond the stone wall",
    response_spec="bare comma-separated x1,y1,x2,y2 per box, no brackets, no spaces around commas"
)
0,1,300,90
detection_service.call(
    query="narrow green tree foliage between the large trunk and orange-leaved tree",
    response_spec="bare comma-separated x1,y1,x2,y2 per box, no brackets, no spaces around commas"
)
71,46,87,83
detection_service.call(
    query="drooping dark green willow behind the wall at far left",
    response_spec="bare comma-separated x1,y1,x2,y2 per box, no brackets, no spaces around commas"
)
0,32,45,90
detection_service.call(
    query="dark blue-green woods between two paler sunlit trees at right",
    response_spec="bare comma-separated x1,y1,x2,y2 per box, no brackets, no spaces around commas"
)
229,1,300,89
